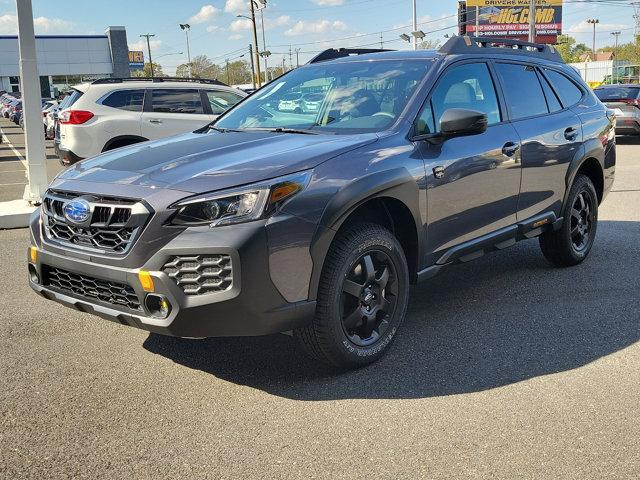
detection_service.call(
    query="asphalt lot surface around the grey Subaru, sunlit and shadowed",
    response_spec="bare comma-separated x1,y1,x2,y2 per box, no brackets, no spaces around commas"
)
0,133,640,479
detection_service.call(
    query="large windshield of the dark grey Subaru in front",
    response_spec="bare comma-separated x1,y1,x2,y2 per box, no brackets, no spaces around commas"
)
215,60,432,133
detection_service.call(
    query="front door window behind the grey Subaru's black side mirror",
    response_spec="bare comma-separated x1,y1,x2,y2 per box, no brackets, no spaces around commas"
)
416,63,501,134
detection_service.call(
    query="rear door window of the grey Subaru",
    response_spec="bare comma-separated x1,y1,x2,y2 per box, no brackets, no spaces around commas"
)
496,63,549,120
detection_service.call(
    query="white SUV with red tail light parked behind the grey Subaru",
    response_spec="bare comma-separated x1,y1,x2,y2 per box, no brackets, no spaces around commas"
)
55,78,247,165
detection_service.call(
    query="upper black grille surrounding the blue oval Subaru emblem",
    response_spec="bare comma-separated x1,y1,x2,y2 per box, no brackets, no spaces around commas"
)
42,190,149,254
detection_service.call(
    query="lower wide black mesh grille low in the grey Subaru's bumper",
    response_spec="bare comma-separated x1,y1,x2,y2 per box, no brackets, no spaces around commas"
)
43,265,142,311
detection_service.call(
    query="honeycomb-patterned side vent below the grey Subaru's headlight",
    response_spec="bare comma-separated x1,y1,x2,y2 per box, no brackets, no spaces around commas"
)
162,254,233,295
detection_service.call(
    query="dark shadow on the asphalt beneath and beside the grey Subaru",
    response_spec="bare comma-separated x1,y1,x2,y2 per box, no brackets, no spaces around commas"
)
144,221,640,400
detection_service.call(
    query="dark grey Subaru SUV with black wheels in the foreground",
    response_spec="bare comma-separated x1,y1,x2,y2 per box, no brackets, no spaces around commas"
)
28,36,616,368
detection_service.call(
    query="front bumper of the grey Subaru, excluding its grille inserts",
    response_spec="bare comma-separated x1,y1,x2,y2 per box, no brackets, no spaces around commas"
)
29,218,315,337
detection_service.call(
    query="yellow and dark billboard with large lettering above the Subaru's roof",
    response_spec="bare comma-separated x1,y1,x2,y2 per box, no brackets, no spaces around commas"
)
460,0,562,43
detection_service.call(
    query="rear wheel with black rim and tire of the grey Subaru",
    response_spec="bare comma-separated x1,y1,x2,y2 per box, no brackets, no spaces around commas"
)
540,175,598,267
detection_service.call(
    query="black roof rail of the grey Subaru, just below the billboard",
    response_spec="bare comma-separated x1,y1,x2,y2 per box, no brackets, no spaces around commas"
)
438,35,564,62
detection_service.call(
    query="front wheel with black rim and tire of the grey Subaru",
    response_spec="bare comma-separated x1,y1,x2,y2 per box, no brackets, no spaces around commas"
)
294,224,409,368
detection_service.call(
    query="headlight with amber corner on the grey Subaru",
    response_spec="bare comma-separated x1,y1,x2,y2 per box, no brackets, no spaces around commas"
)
169,172,311,227
